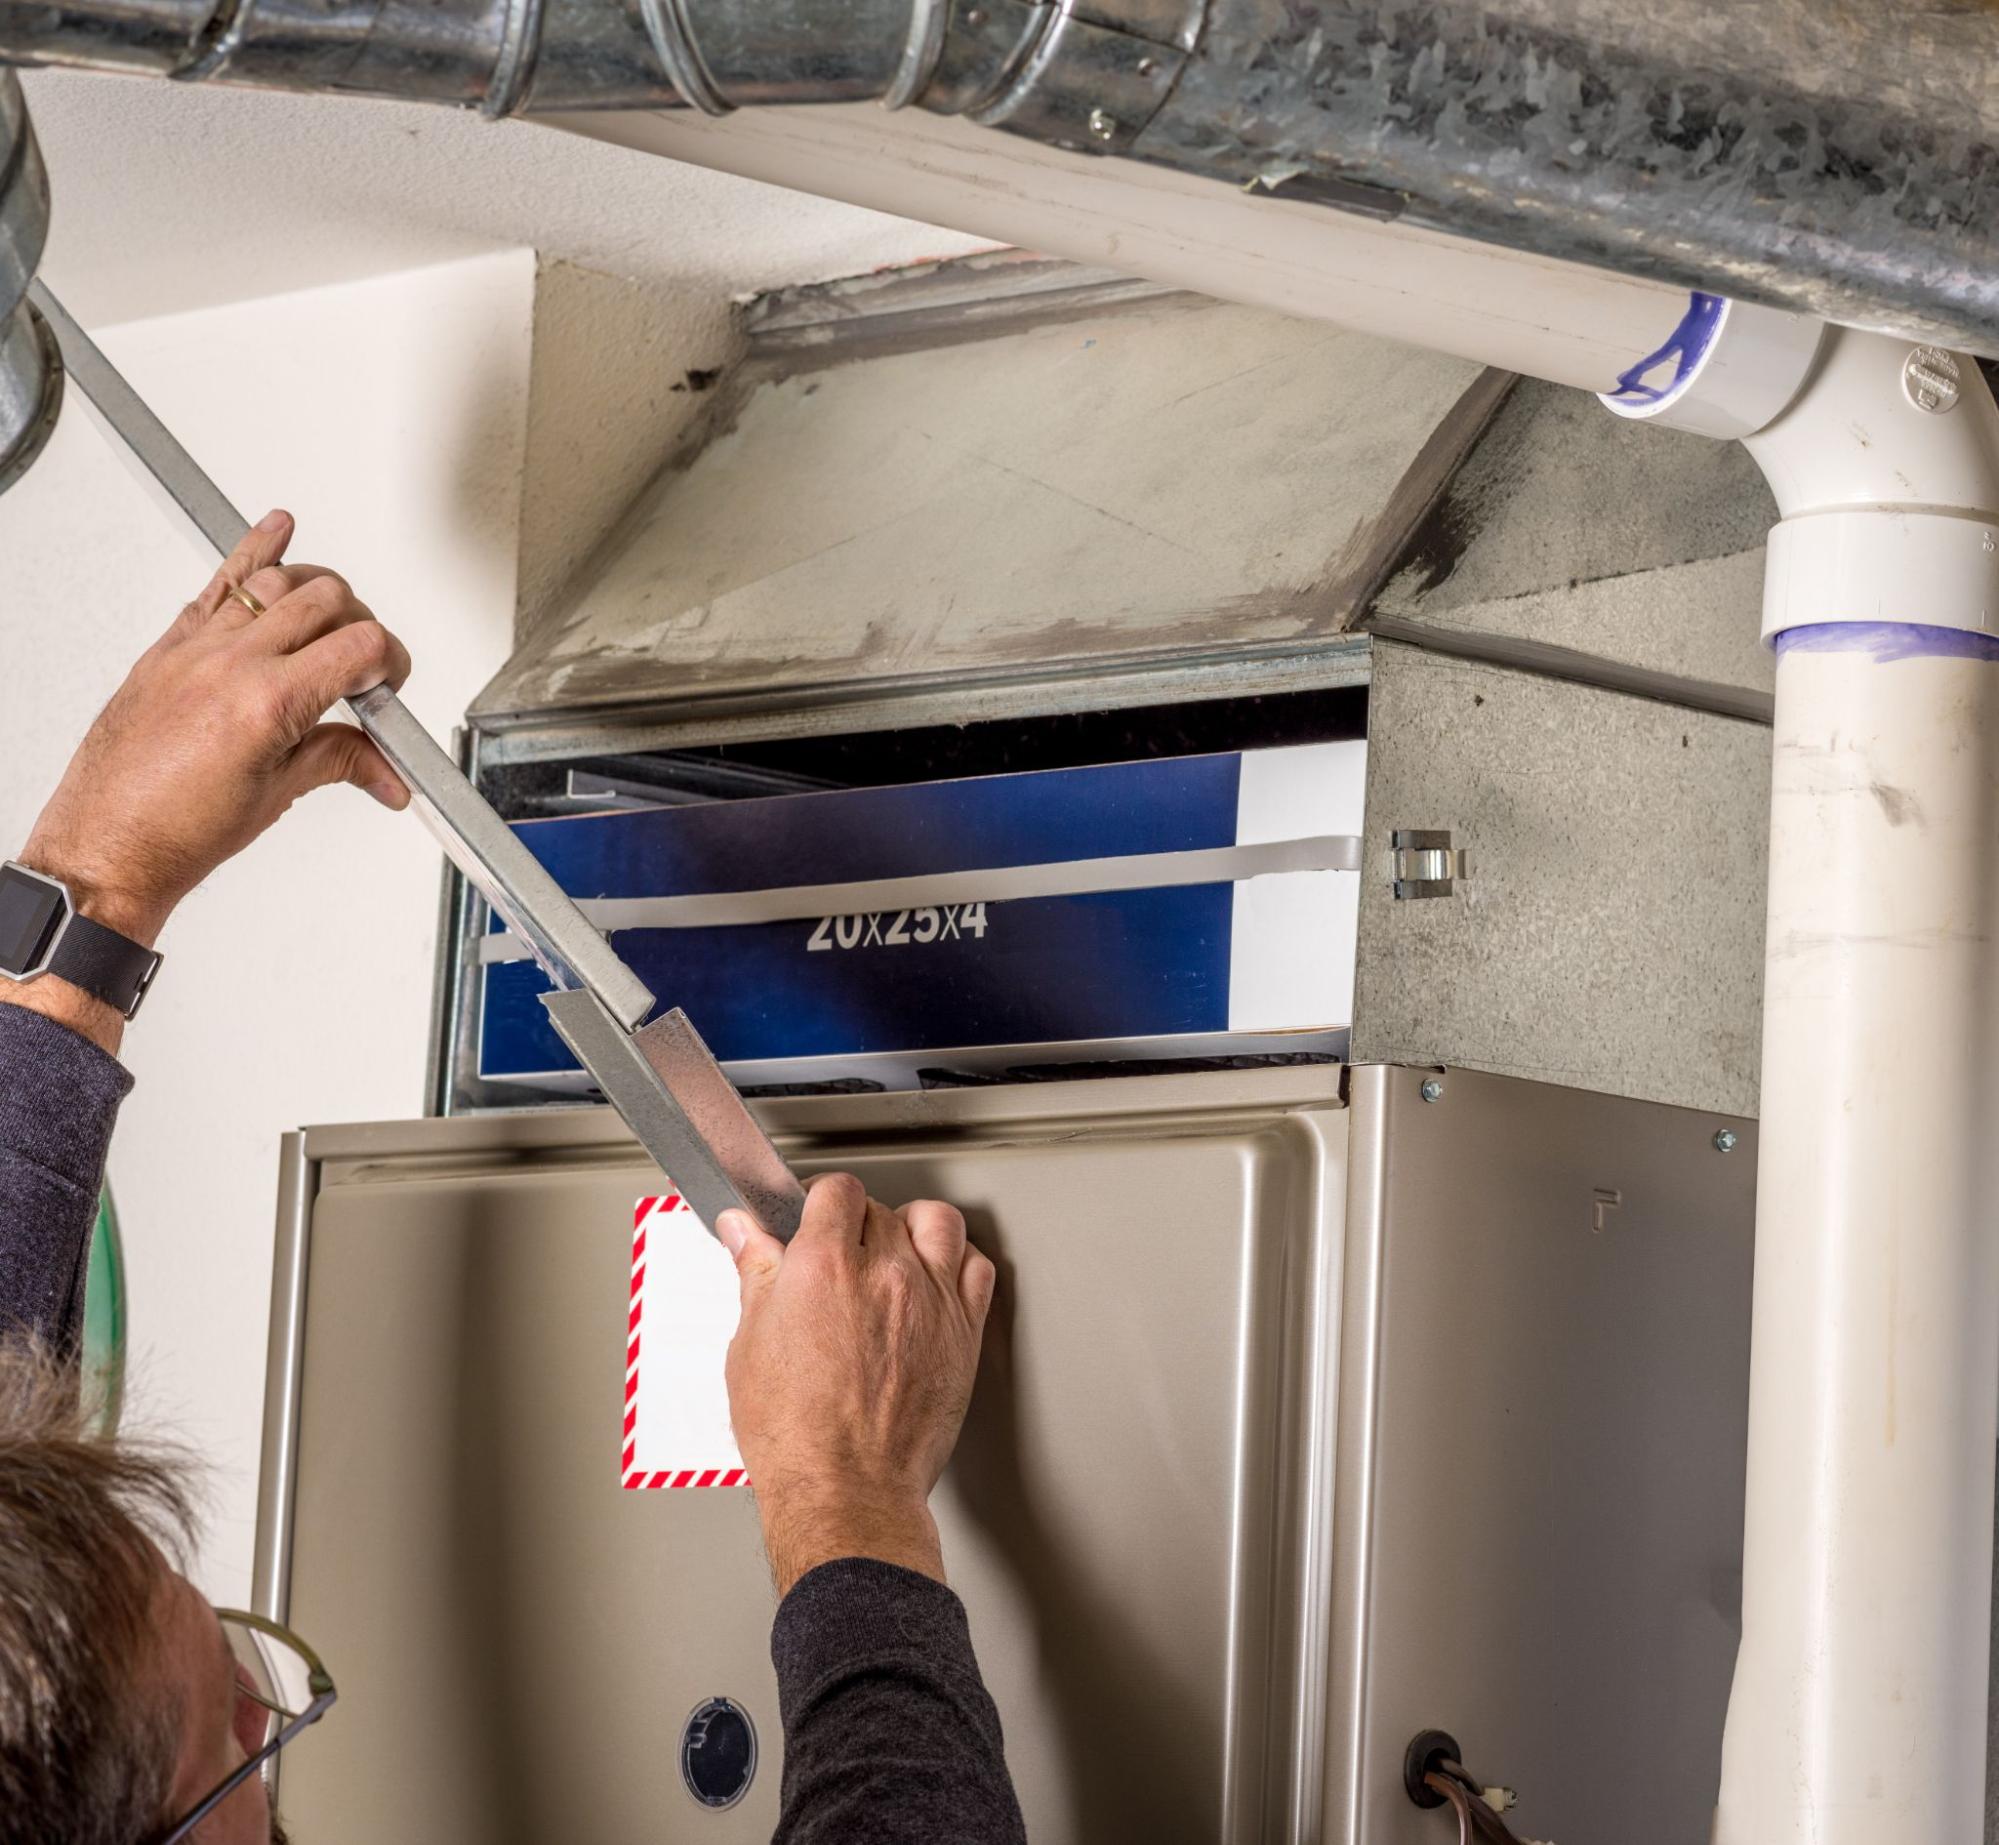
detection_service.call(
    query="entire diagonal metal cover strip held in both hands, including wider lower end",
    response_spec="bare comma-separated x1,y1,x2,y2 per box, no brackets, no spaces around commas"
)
34,282,806,1223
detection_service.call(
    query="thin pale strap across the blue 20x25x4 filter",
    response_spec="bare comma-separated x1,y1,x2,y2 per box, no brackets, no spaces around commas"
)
480,834,1361,965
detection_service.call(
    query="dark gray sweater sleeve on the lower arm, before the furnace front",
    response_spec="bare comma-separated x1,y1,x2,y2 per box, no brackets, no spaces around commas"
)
770,1557,1027,1845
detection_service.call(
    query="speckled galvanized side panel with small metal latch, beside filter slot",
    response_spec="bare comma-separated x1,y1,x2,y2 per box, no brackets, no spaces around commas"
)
1353,642,1769,1115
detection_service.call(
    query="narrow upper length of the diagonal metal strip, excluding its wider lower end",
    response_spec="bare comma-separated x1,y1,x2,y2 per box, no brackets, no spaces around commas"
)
30,282,654,1025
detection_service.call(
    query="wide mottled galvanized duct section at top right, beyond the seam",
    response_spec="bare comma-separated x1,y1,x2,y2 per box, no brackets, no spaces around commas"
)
1133,0,1999,354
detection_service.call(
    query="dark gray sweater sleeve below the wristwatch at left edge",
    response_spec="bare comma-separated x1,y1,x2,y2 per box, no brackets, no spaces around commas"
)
0,1005,132,1353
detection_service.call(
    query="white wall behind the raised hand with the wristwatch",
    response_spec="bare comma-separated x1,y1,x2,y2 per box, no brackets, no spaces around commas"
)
0,248,534,1605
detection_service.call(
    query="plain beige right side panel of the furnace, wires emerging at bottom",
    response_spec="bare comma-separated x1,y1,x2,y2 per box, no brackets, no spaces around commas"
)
1327,1065,1755,1845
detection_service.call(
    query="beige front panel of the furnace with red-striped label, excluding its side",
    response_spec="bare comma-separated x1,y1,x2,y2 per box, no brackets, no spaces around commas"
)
264,1067,1345,1845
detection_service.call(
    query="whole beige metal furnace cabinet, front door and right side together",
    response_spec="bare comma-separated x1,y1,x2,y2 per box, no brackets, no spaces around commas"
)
258,1065,1755,1845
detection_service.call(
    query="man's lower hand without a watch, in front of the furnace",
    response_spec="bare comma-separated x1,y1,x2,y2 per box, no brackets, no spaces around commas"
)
716,1173,994,1595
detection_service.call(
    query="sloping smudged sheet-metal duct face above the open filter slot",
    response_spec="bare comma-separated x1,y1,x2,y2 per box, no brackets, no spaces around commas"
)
472,260,1491,734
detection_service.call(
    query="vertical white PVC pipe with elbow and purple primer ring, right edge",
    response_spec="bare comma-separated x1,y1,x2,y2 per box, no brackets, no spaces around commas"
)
1715,330,1999,1845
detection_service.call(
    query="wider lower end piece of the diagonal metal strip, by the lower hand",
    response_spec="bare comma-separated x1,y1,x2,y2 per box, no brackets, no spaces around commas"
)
542,991,806,1243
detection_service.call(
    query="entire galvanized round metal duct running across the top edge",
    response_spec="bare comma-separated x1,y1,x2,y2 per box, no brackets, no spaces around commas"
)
0,0,1999,352
